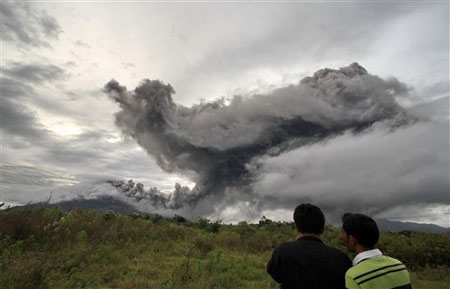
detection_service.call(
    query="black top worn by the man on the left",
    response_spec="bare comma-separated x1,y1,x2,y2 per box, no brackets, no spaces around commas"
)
267,236,352,289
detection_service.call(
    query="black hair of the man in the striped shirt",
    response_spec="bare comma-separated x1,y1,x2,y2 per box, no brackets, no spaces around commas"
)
342,213,380,249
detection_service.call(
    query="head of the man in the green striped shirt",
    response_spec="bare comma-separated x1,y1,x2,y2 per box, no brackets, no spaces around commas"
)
342,213,380,252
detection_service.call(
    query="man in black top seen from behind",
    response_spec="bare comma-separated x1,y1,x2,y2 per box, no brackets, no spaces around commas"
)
267,204,352,289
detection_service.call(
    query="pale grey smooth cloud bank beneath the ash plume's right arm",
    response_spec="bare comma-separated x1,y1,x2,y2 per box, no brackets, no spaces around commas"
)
253,121,449,215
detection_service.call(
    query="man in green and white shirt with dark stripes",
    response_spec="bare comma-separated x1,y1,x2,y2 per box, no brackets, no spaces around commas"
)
342,213,411,289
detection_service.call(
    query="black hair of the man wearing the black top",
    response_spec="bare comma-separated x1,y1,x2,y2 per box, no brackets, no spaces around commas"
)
294,204,325,234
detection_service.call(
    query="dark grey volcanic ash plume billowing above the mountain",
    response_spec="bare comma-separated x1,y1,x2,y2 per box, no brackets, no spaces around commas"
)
104,63,415,209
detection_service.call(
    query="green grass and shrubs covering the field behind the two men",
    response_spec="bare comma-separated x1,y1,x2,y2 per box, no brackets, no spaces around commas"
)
0,208,450,289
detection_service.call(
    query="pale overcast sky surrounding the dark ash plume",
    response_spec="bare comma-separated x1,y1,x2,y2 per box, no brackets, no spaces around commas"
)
1,1,450,226
